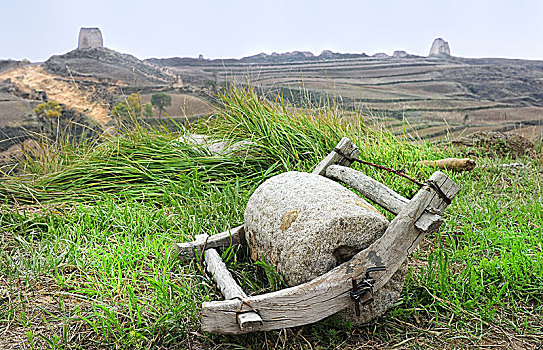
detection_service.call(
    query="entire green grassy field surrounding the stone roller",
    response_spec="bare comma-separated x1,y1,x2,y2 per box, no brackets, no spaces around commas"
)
0,86,543,349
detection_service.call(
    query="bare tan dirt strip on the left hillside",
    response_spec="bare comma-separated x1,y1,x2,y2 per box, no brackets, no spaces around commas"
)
0,66,111,126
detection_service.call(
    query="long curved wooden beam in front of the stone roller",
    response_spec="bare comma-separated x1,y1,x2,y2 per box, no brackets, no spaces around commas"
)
202,172,458,334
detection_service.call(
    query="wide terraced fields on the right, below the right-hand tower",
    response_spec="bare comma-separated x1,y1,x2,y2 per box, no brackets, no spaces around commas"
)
153,56,543,141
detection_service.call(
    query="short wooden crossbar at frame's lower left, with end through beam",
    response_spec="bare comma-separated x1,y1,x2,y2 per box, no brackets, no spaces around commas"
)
205,248,262,332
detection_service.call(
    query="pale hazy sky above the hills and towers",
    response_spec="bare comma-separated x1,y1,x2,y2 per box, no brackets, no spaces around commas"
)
0,0,543,61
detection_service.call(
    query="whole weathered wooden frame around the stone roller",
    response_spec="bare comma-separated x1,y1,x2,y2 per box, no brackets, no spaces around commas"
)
176,138,459,334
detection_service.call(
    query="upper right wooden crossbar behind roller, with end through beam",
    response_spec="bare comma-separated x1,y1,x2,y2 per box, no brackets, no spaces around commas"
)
326,165,450,233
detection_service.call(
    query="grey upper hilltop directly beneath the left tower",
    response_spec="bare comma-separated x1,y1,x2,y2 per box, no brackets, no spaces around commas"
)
43,47,182,87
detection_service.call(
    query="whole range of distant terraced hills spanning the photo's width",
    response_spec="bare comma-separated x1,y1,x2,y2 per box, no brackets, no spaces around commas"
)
4,47,543,148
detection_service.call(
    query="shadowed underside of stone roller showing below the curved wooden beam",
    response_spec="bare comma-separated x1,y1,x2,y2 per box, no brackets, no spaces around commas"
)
336,260,408,325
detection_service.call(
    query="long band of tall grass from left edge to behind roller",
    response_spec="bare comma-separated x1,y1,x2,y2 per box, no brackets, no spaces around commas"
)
0,87,450,204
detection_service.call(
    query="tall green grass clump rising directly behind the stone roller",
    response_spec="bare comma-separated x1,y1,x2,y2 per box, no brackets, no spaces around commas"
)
195,86,451,196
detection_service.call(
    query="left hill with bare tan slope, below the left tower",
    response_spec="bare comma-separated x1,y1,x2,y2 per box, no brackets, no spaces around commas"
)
0,47,210,151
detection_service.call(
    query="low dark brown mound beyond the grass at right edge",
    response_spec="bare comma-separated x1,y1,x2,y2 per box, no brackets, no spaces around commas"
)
451,131,537,158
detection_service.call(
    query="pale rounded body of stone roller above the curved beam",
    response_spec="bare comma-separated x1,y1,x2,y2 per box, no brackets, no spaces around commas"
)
245,172,389,286
